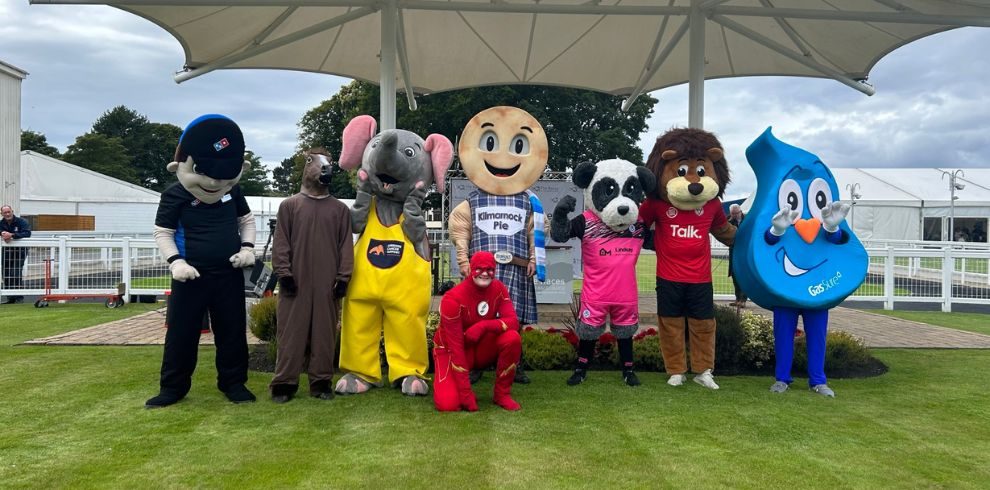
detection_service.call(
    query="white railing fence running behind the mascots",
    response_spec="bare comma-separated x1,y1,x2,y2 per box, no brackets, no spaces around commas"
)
0,236,990,311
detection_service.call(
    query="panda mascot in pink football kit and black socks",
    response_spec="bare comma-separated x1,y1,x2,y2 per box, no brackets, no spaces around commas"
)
550,159,656,386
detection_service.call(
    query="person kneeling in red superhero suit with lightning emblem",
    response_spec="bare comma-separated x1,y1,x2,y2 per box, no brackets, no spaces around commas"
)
433,251,522,412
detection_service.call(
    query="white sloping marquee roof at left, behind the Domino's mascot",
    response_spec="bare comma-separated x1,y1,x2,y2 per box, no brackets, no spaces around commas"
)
20,150,159,203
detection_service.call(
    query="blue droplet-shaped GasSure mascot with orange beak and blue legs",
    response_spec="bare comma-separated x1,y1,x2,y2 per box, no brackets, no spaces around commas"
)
731,128,869,397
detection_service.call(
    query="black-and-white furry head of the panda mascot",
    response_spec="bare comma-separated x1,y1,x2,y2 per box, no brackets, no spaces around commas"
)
574,159,656,231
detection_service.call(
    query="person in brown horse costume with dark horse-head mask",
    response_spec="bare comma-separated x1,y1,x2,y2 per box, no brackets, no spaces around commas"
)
269,148,354,403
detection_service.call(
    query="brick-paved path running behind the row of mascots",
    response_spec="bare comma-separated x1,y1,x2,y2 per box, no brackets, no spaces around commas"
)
19,295,990,349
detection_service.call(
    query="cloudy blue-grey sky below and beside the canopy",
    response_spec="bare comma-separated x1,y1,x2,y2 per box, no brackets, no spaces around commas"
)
0,0,990,197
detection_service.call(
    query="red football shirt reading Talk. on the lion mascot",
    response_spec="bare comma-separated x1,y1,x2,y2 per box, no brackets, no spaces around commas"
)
639,198,728,284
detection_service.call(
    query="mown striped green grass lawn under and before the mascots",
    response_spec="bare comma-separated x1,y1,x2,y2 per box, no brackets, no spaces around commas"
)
0,304,990,489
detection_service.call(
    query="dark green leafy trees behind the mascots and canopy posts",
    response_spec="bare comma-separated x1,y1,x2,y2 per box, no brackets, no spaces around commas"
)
21,81,657,207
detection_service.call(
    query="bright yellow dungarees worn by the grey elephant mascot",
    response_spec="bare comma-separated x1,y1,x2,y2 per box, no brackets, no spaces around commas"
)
340,198,430,384
